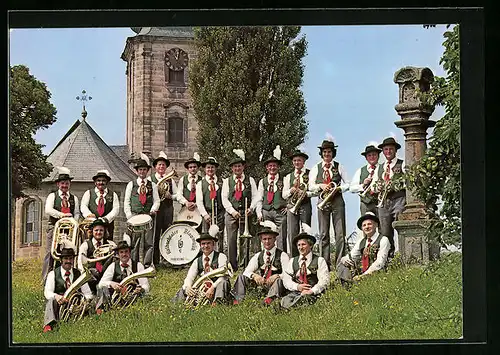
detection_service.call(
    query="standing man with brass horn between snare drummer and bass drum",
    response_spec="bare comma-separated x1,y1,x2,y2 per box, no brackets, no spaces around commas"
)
148,152,177,265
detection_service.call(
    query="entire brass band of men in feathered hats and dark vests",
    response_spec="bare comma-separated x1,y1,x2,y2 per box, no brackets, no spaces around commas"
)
42,137,406,332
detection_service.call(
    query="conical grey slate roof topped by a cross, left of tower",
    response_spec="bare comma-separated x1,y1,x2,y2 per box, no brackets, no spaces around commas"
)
44,114,136,182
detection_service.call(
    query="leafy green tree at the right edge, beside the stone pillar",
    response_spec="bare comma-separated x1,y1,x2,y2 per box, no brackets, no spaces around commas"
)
407,25,462,248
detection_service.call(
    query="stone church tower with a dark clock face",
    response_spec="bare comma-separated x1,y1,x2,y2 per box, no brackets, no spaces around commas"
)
121,27,198,173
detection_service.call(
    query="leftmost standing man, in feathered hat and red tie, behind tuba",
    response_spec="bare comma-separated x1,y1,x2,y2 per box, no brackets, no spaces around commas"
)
42,167,80,283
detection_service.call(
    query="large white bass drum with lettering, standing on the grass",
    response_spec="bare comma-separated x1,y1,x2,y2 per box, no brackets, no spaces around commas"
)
159,223,200,265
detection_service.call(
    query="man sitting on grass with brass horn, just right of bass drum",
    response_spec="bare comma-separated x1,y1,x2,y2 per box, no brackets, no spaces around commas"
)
172,224,231,305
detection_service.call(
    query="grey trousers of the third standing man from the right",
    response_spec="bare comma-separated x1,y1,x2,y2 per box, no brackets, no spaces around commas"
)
318,196,346,270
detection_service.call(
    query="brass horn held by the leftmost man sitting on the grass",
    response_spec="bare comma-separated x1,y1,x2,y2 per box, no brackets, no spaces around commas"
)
59,267,94,322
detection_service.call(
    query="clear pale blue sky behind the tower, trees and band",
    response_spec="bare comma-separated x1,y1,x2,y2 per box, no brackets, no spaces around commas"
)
9,25,446,239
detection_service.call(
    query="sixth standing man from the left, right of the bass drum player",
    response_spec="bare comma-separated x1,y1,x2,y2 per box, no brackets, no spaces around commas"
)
196,157,225,252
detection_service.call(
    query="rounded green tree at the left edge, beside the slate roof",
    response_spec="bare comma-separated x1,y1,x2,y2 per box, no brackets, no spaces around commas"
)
9,65,57,199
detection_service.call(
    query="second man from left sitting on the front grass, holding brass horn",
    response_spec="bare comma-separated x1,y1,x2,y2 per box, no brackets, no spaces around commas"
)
96,241,149,314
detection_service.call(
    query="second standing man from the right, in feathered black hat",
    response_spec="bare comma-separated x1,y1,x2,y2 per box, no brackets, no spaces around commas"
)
349,142,382,216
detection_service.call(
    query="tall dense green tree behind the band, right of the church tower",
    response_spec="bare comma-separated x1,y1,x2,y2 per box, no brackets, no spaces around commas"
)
189,26,308,177
